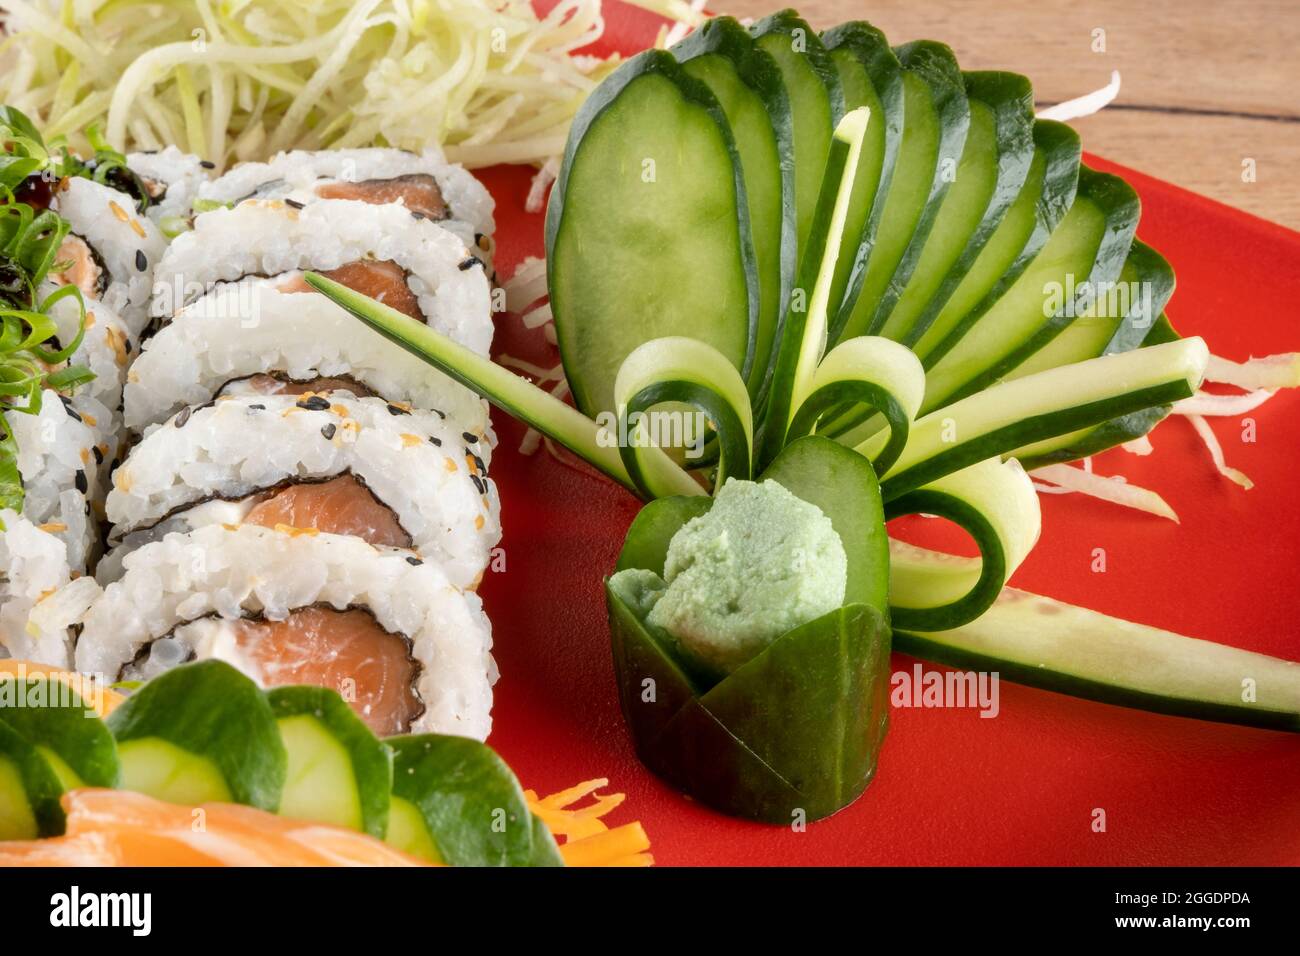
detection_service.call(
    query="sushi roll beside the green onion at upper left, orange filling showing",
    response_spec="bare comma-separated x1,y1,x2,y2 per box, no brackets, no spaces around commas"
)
51,177,166,336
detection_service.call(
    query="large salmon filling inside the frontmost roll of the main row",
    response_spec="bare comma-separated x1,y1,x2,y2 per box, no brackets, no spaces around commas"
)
233,607,424,736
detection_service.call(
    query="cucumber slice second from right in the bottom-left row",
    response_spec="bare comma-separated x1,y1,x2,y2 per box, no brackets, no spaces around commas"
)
267,687,393,838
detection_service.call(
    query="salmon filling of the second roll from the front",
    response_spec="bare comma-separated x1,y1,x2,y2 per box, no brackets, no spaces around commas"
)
244,475,411,548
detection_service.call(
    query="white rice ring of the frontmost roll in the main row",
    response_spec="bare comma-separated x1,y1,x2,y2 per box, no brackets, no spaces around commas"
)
75,525,497,740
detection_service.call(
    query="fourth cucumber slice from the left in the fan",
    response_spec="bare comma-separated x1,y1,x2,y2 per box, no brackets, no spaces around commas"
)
822,21,904,348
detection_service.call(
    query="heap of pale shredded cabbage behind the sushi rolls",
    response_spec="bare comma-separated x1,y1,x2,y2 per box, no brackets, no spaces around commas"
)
0,0,703,166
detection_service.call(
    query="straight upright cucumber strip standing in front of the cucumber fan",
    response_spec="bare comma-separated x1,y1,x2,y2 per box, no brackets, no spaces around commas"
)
761,107,871,464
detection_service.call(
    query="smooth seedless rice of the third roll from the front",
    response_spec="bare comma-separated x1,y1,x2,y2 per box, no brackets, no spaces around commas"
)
125,280,490,432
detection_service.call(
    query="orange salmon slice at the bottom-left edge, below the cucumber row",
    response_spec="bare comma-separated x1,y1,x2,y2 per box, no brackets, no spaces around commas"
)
0,790,433,866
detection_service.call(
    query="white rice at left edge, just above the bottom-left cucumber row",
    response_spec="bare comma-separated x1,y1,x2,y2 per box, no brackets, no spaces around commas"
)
0,509,99,667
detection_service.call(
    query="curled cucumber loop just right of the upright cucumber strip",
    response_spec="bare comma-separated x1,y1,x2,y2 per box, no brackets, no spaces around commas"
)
787,336,926,475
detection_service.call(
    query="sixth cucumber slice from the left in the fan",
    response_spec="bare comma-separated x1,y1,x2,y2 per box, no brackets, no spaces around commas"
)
880,72,1034,346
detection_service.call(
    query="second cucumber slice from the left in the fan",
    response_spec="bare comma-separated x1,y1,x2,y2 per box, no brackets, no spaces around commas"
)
670,17,798,395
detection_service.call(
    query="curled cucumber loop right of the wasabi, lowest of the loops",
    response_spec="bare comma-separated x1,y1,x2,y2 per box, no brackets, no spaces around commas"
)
885,458,1043,631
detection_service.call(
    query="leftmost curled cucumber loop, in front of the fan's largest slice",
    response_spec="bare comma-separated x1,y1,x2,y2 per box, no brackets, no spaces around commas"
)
614,336,754,498
